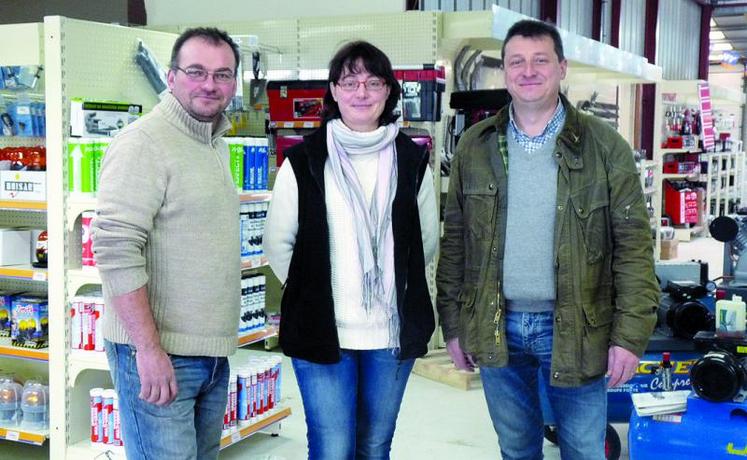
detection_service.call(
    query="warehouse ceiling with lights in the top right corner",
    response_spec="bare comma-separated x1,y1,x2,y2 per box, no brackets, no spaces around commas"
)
708,0,747,62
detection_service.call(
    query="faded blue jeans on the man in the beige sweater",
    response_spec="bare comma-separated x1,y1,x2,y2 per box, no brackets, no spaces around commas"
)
105,341,229,460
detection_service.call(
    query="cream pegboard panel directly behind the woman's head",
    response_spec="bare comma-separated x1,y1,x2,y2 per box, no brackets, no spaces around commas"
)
298,11,440,69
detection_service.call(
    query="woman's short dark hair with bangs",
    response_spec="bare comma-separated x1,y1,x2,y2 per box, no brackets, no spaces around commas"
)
322,41,402,126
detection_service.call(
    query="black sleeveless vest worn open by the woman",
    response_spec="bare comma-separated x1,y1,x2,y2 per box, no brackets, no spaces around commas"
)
276,126,435,364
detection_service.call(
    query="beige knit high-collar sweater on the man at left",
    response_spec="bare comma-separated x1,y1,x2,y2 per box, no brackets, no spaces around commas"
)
93,90,241,356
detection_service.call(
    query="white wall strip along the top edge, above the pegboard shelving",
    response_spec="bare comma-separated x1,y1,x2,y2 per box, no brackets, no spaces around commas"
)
145,0,405,26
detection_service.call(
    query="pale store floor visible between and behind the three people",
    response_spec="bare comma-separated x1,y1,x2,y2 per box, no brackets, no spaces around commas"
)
220,238,723,460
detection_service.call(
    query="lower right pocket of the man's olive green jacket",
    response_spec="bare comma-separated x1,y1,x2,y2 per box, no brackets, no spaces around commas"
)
580,303,613,378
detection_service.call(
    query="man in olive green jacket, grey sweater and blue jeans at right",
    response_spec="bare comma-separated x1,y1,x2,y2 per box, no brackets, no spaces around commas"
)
437,21,659,459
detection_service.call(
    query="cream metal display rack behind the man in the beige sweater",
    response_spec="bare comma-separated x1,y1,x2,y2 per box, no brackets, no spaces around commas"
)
36,16,298,459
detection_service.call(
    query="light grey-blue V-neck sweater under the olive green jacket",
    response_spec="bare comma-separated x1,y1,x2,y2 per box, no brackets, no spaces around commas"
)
503,133,558,311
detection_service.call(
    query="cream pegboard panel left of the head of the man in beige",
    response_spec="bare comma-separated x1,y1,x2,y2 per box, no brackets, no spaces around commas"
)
62,18,176,114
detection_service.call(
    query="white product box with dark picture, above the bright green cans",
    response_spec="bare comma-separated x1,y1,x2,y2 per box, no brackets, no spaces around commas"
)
70,99,143,137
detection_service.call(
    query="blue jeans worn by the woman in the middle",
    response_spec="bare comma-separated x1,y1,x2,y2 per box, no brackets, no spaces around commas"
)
292,350,415,460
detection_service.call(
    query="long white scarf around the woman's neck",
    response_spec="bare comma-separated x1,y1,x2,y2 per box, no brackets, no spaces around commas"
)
327,119,399,349
